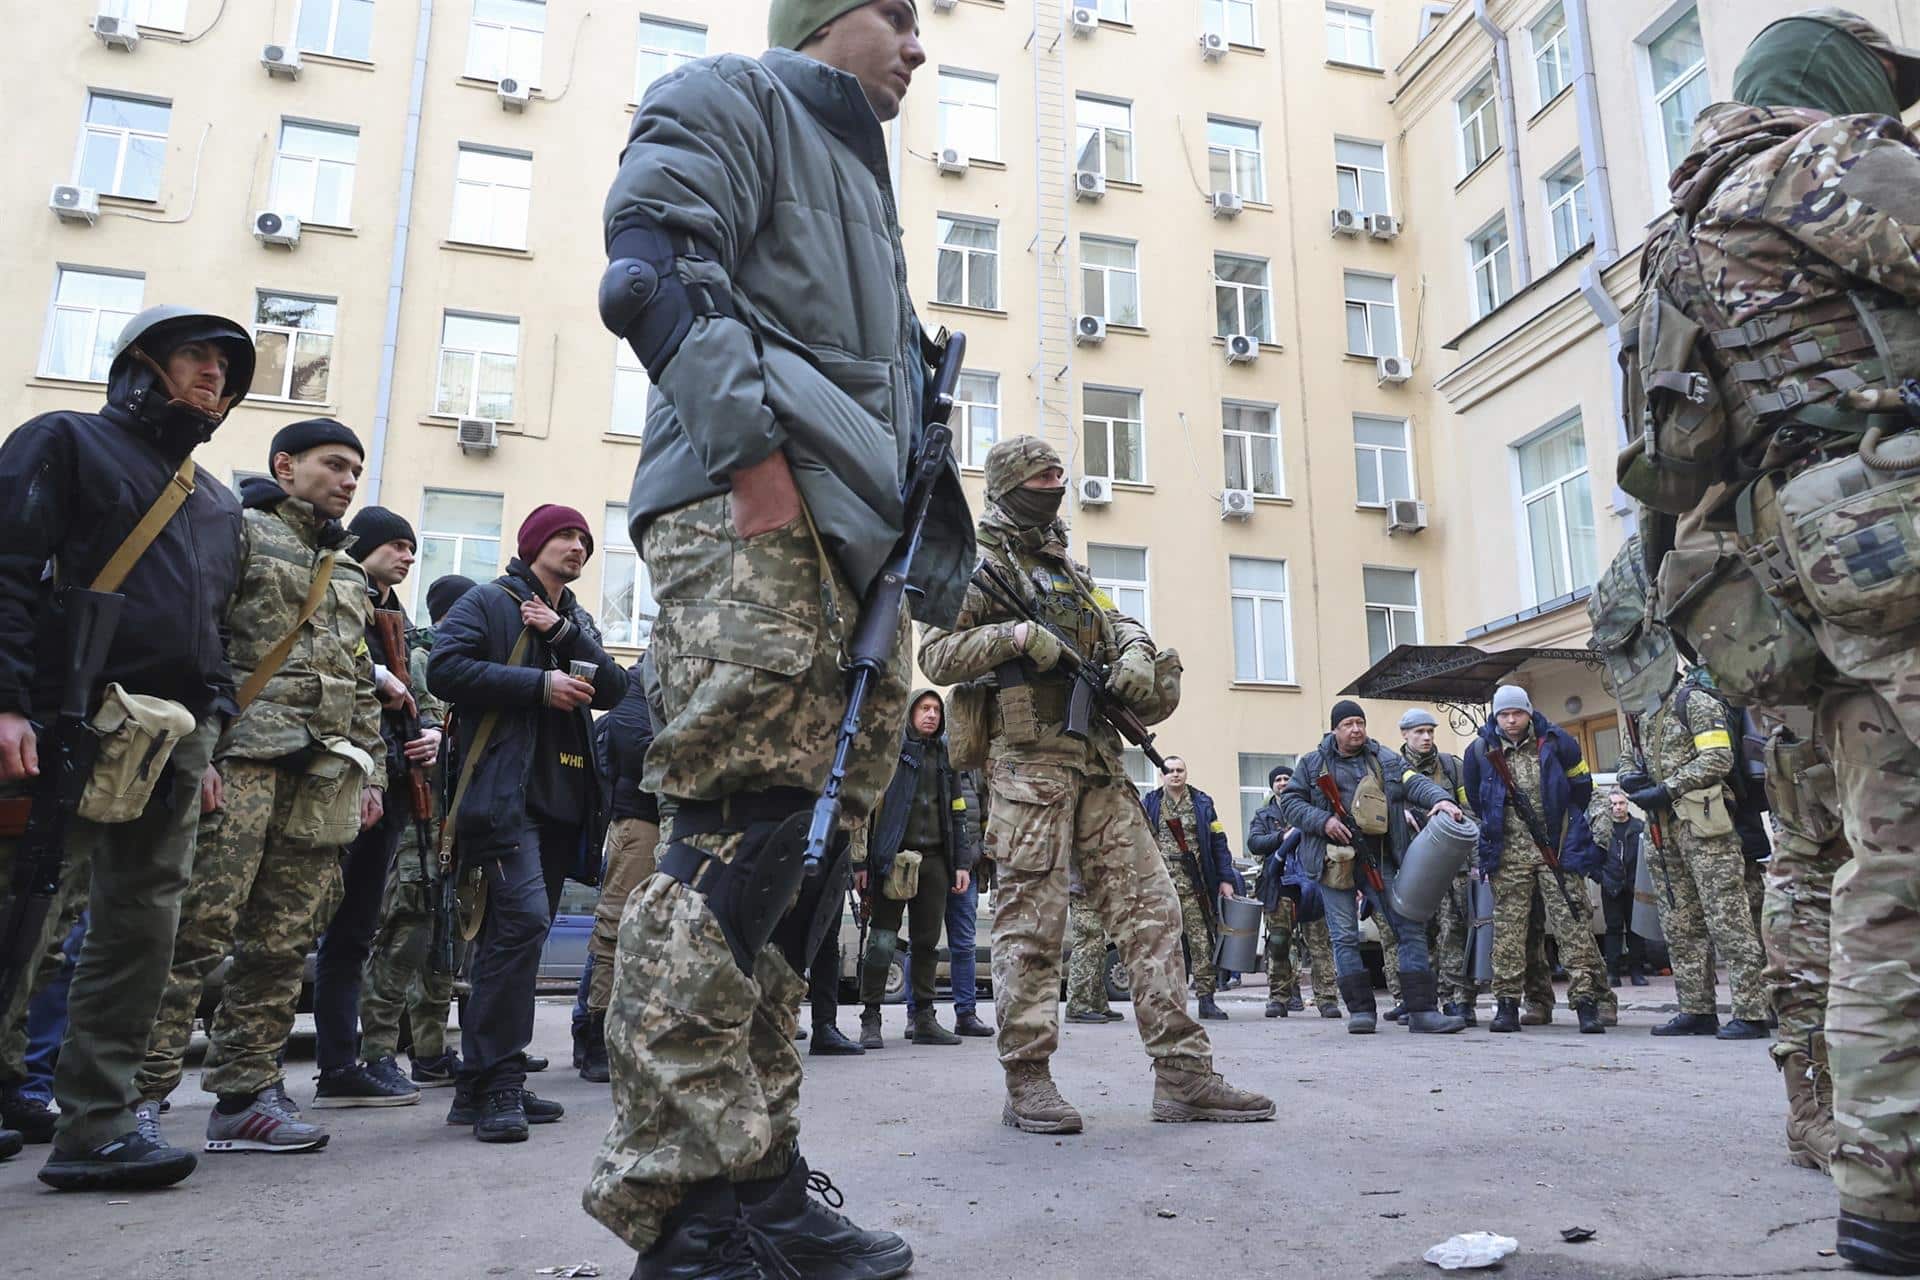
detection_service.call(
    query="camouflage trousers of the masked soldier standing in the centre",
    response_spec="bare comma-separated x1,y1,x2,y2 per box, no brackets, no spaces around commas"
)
985,760,1213,1063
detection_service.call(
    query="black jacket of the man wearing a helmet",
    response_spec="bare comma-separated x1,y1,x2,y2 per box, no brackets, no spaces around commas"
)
0,378,244,723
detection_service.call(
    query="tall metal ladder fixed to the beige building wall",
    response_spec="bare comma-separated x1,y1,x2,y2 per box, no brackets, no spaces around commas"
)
1027,0,1079,458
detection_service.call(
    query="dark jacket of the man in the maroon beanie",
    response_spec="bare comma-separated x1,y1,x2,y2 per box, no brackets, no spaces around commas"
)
426,560,628,862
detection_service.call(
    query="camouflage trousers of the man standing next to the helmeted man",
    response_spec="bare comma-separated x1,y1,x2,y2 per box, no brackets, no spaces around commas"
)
134,760,340,1102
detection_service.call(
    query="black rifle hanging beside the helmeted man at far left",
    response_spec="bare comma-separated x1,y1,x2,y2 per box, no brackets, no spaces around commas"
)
0,587,127,1009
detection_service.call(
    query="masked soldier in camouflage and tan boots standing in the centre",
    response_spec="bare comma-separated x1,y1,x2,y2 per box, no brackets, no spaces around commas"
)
920,436,1273,1132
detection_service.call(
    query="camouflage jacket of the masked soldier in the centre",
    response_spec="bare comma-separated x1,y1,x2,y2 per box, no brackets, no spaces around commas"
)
920,505,1154,777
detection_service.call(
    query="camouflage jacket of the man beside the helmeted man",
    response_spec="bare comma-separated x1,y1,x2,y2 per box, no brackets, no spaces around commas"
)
217,482,386,787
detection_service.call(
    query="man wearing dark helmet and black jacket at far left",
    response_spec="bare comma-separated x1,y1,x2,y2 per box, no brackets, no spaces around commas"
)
0,307,253,1190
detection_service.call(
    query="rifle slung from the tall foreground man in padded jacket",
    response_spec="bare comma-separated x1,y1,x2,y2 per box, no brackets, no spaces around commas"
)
803,334,966,875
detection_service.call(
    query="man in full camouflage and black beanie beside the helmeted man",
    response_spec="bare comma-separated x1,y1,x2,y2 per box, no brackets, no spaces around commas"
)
136,418,386,1153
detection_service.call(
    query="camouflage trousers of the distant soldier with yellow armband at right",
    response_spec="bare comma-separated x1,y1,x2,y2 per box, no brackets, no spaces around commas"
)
1642,816,1766,1021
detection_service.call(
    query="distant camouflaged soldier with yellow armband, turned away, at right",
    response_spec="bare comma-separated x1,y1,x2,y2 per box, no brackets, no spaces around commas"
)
1620,672,1766,1040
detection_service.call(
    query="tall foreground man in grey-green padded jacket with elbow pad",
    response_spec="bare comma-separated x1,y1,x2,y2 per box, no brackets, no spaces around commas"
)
584,0,975,1280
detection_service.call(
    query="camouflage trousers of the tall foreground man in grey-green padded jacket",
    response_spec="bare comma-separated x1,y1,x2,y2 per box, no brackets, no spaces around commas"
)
582,493,910,1251
